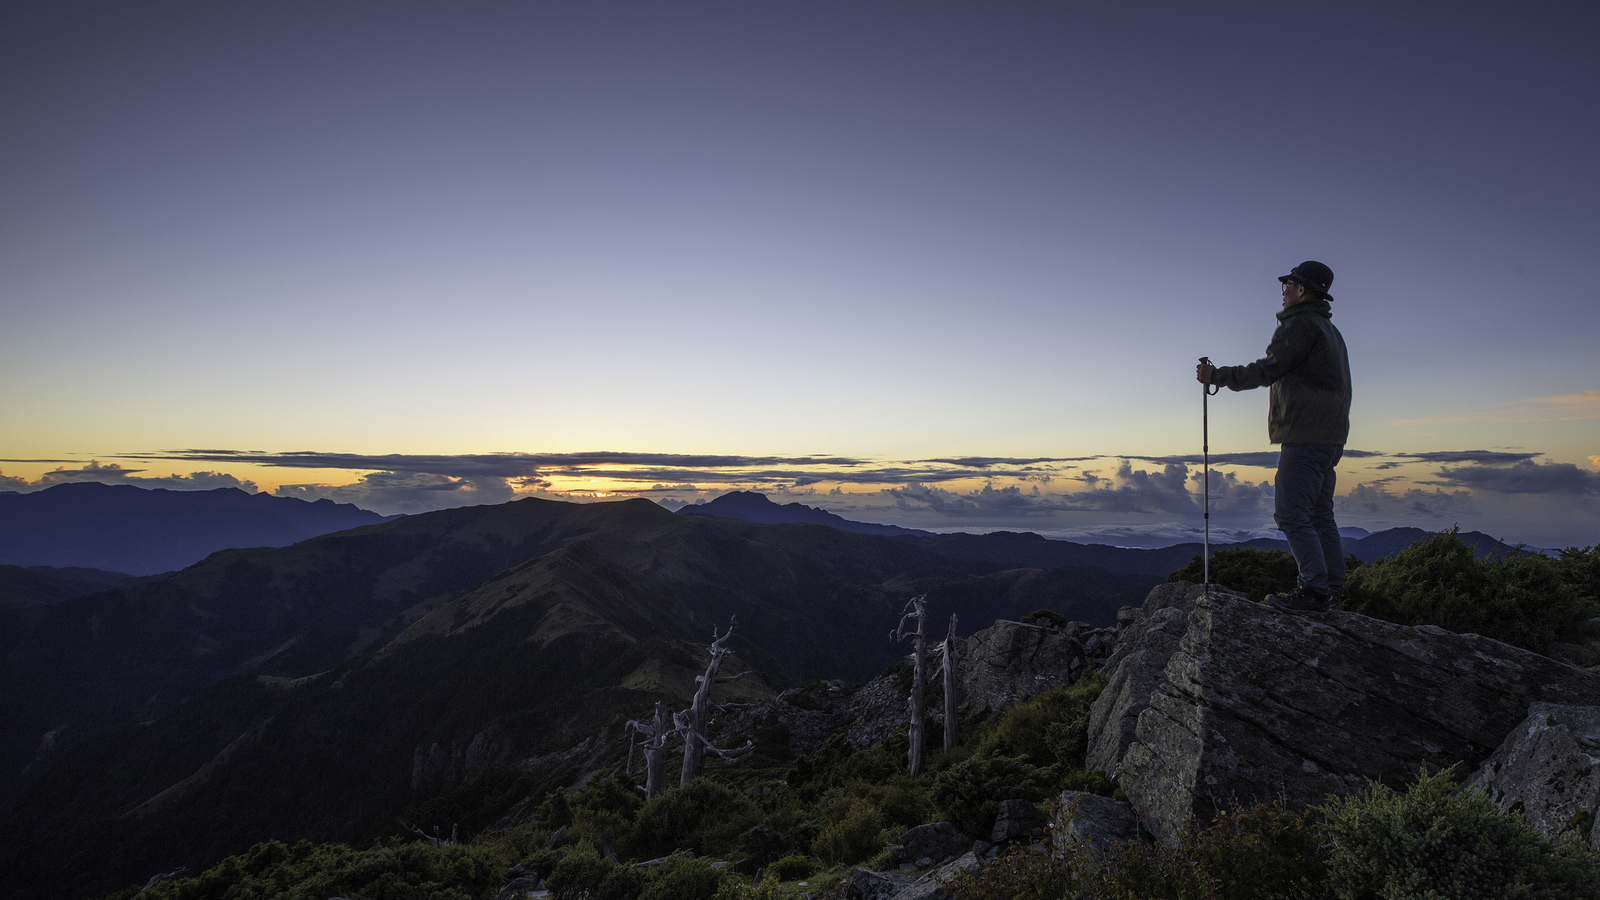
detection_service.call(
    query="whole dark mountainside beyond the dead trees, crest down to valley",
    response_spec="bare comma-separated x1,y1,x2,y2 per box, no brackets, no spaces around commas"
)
0,500,1154,887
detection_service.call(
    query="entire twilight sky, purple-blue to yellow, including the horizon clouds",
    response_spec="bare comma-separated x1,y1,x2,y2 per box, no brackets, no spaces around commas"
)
0,0,1600,548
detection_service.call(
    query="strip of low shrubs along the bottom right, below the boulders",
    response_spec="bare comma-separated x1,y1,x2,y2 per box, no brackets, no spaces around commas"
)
955,770,1600,900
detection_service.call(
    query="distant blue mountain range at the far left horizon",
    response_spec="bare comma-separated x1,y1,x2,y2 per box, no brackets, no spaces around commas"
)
0,482,387,575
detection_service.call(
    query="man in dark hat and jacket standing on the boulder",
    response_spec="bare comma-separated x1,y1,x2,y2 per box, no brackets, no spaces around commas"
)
1195,261,1350,612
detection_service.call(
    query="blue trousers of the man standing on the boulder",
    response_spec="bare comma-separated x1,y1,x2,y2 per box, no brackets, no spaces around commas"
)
1272,444,1344,593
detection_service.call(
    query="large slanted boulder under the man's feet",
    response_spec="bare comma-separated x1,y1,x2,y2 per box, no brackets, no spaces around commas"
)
1088,583,1600,841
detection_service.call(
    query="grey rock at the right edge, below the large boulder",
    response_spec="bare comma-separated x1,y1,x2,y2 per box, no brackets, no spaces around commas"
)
1464,703,1600,850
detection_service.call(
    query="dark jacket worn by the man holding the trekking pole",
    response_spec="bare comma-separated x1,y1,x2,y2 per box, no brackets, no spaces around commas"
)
1211,299,1350,445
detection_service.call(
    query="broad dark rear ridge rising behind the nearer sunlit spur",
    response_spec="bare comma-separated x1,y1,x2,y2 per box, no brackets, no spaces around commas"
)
0,500,1158,797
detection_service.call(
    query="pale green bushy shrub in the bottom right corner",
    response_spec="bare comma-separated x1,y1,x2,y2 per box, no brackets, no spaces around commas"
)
1323,770,1600,900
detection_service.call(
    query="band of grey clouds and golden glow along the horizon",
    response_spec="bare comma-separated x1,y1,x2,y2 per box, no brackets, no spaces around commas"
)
0,448,1600,544
